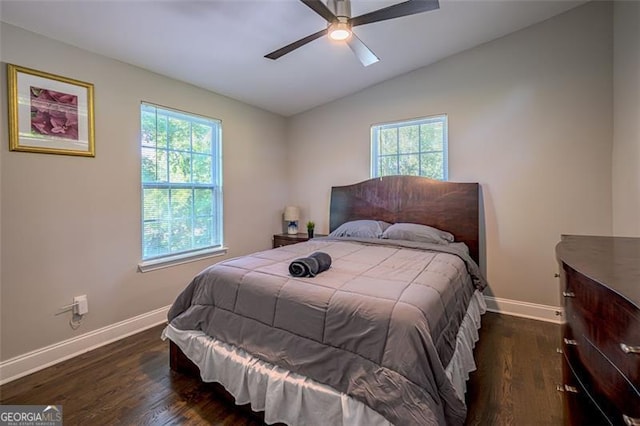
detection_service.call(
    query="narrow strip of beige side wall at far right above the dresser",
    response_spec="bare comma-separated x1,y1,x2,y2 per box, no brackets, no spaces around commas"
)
613,1,640,237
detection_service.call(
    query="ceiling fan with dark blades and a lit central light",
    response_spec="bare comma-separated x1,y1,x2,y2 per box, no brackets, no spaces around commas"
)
265,0,440,67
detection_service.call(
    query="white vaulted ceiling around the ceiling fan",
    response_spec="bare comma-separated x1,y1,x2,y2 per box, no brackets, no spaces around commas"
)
0,0,584,116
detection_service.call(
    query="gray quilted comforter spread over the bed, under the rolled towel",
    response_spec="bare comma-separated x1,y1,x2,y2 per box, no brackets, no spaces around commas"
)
168,239,486,425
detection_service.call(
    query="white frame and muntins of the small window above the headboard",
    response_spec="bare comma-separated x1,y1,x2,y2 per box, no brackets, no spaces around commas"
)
371,114,449,181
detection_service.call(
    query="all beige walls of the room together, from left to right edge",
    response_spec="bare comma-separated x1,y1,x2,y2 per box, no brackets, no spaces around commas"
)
0,2,640,360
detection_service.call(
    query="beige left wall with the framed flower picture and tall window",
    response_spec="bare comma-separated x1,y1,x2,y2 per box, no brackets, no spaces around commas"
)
0,23,288,360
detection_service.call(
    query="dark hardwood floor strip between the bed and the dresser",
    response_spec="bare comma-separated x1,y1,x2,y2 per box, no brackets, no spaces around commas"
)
466,312,562,426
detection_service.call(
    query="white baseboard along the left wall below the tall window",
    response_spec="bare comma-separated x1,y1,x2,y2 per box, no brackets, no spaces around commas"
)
0,306,170,385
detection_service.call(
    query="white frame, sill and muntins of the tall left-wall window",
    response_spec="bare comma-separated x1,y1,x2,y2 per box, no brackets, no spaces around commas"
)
138,102,227,272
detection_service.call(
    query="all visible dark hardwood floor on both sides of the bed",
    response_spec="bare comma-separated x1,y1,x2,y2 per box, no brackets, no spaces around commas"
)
0,313,562,426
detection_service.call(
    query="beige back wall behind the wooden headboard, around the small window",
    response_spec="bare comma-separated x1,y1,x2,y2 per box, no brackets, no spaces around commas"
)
288,3,613,305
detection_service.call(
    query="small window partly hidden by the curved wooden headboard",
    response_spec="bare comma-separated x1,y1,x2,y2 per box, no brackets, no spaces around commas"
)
371,115,448,180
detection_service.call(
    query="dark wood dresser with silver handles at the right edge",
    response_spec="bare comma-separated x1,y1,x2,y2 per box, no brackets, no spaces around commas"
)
556,235,640,425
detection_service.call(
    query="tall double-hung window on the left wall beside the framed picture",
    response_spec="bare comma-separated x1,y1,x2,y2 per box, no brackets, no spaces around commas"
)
140,103,222,264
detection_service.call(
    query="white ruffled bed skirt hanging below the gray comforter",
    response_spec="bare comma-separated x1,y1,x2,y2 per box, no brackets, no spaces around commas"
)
162,291,486,426
